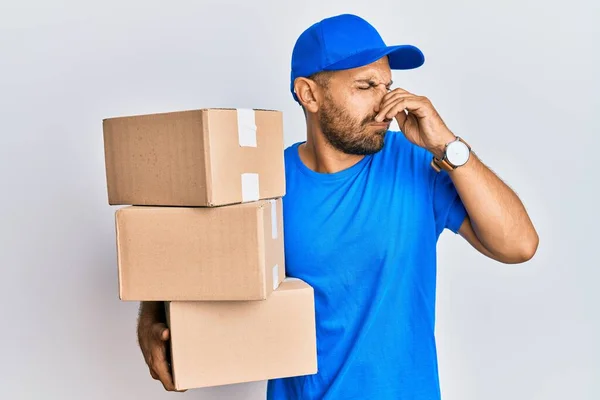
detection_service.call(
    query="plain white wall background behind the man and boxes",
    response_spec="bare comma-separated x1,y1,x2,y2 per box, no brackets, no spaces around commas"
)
0,0,600,400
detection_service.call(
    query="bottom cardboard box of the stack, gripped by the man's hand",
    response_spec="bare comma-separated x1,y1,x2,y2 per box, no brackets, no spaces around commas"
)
166,278,317,390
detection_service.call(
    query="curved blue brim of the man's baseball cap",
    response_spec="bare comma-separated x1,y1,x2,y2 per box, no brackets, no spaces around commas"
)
325,44,425,71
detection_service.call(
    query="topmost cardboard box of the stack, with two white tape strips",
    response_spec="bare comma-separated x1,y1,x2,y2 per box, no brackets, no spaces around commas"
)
103,108,285,206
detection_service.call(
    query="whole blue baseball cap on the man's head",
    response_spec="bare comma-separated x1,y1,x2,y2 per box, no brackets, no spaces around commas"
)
290,14,425,102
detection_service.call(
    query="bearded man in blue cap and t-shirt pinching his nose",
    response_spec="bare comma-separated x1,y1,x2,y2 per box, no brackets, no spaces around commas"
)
139,14,538,400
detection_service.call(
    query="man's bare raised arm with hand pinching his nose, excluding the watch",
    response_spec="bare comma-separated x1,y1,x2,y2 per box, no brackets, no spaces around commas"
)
375,88,538,264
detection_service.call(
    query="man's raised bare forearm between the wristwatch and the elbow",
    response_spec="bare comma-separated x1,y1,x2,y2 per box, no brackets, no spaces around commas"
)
450,153,538,260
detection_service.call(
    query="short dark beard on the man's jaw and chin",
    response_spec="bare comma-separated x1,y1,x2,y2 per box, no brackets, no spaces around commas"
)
319,96,387,155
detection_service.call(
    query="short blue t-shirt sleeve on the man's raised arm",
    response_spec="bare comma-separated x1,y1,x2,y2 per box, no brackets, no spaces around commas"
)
433,171,467,236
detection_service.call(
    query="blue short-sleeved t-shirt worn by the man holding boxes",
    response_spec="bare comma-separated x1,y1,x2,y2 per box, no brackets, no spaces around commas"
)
267,131,467,400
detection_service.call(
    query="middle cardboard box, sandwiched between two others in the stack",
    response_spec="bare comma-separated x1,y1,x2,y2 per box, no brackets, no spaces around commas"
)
116,199,285,301
